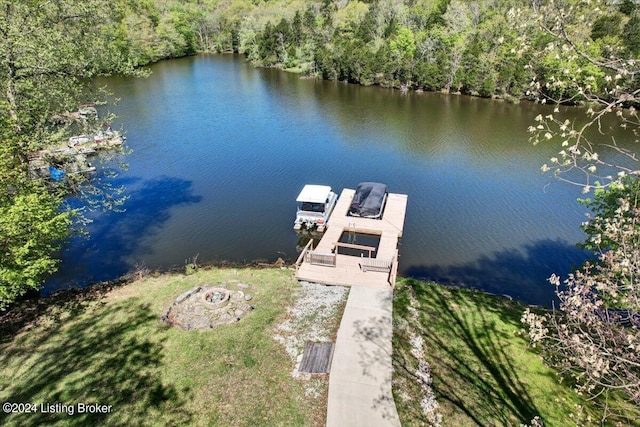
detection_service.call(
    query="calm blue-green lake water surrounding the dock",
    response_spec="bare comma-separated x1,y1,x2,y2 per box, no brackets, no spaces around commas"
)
43,55,608,304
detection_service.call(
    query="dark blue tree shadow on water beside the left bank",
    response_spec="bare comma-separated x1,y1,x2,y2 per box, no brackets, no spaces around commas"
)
42,176,202,296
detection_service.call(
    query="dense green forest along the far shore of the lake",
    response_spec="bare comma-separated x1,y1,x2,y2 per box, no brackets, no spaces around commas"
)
119,0,640,99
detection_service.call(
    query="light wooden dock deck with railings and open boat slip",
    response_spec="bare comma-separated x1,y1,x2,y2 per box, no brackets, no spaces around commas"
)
296,189,407,288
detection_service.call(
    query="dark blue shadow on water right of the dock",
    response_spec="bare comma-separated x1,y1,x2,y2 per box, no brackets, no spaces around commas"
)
403,239,590,306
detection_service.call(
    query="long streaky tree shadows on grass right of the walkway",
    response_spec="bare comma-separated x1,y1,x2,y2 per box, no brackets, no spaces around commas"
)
394,279,540,425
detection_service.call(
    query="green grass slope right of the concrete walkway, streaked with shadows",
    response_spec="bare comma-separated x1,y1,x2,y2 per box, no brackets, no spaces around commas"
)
394,279,638,426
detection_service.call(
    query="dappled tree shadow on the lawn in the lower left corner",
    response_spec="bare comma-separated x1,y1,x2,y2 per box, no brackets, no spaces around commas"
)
0,289,191,426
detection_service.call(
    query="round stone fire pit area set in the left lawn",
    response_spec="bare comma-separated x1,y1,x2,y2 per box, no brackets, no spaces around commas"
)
162,283,253,330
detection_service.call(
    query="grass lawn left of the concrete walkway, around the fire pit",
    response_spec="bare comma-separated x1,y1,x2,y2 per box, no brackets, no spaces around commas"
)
0,269,338,426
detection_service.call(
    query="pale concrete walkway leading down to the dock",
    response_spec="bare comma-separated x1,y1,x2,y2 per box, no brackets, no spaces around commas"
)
327,286,400,427
